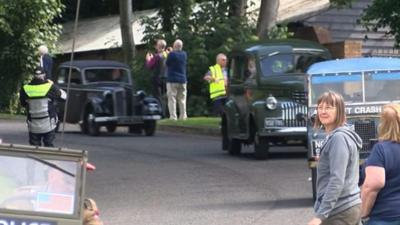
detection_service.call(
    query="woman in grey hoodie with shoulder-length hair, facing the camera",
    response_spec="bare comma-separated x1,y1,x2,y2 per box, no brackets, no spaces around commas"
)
308,91,362,225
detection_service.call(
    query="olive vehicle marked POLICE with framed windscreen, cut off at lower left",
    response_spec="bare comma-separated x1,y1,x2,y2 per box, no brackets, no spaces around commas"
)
0,144,87,225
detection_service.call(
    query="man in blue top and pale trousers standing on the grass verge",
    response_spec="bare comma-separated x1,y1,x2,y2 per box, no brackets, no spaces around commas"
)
166,39,187,120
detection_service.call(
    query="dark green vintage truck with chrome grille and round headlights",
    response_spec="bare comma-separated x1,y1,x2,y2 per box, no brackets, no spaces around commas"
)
221,39,331,159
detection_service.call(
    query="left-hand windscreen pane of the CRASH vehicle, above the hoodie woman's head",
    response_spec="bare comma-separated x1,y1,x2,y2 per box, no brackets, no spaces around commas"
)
309,73,363,104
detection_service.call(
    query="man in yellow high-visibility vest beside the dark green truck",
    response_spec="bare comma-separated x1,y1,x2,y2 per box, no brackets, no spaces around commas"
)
204,53,228,115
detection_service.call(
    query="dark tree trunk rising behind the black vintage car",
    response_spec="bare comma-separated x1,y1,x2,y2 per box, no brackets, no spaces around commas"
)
119,0,135,65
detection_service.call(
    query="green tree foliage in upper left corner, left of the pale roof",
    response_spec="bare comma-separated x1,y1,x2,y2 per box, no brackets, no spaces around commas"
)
0,0,63,111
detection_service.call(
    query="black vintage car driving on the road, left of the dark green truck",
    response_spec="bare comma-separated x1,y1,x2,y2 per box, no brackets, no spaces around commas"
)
55,60,162,136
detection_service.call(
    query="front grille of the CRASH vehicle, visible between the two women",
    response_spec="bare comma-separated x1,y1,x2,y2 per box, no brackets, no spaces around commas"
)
349,119,377,153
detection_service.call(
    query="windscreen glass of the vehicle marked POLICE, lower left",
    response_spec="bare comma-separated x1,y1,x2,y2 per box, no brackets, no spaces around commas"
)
0,154,81,216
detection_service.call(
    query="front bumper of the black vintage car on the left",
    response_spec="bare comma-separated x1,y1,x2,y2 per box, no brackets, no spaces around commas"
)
94,115,161,125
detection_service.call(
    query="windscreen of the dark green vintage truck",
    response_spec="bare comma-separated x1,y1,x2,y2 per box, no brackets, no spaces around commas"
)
260,52,325,77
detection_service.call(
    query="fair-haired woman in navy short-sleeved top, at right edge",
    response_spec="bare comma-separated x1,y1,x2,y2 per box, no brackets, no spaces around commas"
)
361,104,400,225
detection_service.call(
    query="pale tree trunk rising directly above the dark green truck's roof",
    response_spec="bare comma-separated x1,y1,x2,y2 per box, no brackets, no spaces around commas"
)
257,0,279,39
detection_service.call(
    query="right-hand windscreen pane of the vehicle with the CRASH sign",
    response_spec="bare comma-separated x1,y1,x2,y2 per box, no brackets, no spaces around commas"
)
365,71,400,101
